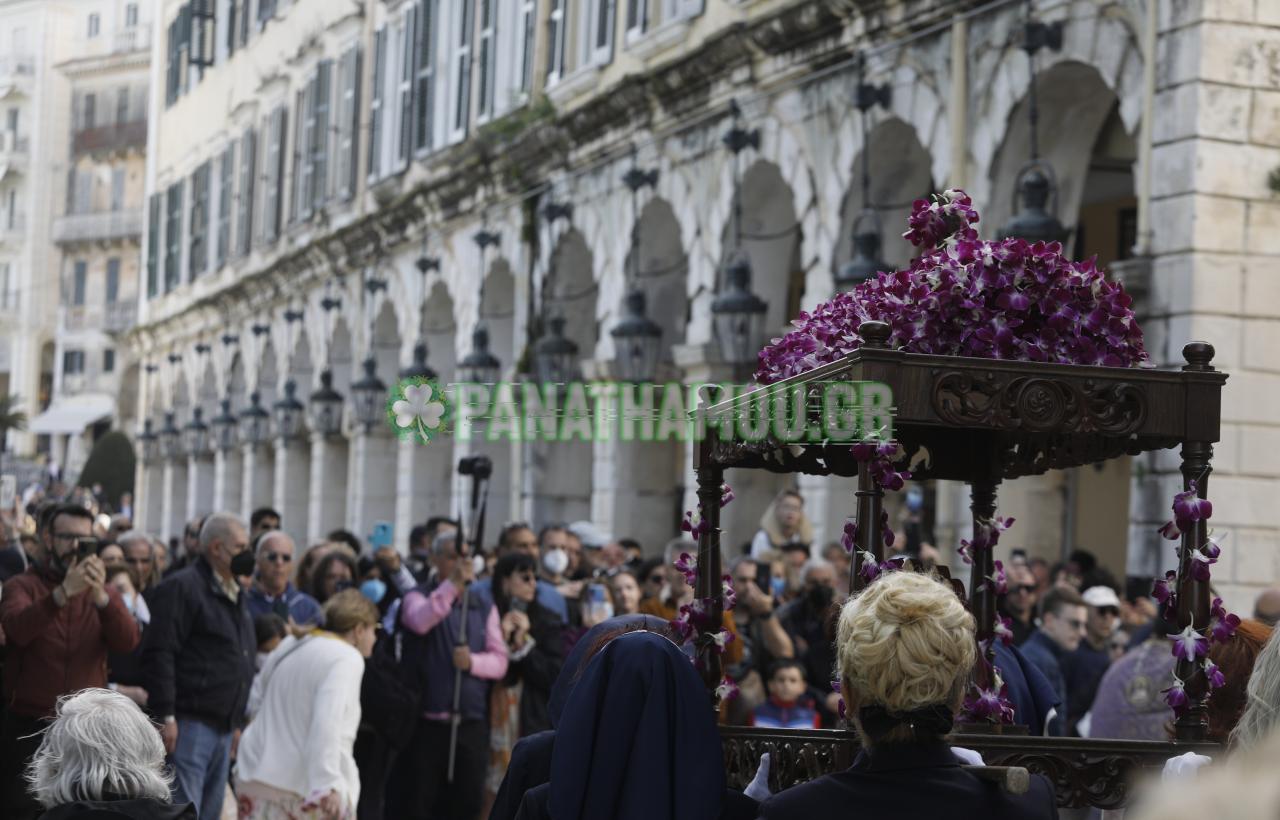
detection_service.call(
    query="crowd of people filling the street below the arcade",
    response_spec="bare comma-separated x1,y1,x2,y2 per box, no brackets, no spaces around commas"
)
0,490,1280,820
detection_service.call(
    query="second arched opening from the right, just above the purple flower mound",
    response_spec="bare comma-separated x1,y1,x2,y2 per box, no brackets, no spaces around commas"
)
832,116,936,278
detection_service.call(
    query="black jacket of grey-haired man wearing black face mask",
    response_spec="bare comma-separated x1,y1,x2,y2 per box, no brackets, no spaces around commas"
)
142,558,257,732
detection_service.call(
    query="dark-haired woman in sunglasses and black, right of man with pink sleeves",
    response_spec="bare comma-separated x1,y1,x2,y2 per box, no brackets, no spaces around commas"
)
483,553,564,816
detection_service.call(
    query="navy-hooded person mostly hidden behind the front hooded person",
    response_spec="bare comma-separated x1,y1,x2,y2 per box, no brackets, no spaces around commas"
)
489,615,671,820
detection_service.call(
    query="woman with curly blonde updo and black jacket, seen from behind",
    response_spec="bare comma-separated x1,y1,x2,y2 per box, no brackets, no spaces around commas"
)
760,572,1057,820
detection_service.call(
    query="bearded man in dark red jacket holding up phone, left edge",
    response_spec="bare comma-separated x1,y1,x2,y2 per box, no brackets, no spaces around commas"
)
0,504,140,819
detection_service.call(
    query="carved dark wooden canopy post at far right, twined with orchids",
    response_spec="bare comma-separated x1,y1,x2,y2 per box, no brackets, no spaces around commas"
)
1174,342,1213,741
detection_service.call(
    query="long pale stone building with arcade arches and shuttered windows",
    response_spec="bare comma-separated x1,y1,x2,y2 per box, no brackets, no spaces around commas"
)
131,0,1280,614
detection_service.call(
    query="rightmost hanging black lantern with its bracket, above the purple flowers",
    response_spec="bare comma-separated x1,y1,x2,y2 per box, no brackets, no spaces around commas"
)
1000,0,1068,242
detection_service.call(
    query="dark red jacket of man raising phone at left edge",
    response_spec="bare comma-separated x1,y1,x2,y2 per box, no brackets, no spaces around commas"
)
0,568,141,718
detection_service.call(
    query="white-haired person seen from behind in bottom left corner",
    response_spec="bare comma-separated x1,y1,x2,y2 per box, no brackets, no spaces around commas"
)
27,690,196,820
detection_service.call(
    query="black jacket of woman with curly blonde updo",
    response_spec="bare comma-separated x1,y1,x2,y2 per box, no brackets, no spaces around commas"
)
760,742,1057,820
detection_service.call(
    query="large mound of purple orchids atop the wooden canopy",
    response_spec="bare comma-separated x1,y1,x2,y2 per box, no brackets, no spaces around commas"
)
755,189,1151,384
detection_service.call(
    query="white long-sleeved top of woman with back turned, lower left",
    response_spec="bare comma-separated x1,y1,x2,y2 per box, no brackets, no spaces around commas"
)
236,632,365,815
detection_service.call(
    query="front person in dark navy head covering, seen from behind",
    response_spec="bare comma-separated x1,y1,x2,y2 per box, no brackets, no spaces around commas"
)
516,632,758,820
